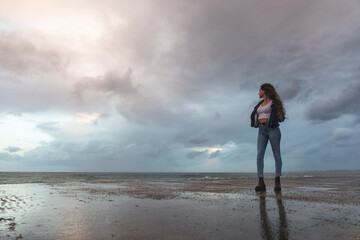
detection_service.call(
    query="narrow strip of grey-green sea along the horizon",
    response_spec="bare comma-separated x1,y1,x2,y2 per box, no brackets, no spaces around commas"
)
0,170,360,184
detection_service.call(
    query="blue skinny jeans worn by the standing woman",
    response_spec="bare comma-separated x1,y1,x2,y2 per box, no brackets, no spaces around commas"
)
256,125,282,177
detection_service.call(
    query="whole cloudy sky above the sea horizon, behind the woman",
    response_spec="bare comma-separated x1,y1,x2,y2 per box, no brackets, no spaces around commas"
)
0,0,360,172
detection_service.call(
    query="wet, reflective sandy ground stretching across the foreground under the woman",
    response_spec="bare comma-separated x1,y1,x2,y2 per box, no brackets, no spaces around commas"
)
0,176,360,240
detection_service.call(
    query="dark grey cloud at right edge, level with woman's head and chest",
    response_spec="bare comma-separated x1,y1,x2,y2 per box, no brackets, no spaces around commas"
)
306,83,360,122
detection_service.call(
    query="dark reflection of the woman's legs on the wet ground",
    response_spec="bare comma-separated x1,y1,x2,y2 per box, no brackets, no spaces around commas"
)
258,192,289,240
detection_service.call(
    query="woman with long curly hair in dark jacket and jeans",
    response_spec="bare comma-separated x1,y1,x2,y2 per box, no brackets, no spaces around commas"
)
250,83,285,191
